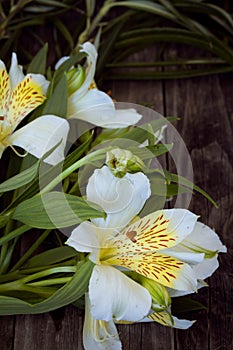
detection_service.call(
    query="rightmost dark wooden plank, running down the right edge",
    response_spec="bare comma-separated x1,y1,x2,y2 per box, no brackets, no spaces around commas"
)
166,75,233,350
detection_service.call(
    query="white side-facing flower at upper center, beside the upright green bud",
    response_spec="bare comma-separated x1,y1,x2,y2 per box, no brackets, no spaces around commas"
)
56,42,142,129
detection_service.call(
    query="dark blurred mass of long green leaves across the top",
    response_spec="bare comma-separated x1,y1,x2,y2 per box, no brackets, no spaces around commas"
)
0,0,233,81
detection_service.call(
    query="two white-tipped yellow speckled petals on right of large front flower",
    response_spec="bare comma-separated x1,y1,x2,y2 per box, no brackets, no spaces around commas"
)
106,209,197,291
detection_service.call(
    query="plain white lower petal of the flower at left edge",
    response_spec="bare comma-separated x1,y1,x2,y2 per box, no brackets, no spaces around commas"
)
8,115,69,165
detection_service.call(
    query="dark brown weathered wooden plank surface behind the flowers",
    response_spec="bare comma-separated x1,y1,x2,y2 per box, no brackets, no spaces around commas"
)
0,47,233,350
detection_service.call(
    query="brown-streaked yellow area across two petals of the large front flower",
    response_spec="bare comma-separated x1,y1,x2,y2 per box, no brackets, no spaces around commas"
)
104,211,190,288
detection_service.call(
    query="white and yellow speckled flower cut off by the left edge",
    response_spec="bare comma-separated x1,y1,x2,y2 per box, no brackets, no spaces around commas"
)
0,53,69,164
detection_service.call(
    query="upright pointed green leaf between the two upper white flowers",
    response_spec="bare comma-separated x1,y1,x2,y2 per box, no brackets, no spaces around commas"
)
43,75,68,118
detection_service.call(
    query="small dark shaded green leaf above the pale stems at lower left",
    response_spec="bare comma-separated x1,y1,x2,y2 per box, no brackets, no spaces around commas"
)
26,246,78,268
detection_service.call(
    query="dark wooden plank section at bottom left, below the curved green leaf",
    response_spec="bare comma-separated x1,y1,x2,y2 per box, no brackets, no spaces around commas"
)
14,306,83,350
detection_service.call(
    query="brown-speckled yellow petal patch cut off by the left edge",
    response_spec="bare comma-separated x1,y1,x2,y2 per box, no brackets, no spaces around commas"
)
0,69,10,116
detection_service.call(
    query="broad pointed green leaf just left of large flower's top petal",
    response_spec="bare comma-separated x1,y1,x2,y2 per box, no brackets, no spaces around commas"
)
13,192,105,229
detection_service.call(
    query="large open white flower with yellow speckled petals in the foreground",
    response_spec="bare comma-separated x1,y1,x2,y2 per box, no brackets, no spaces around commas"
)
67,166,206,350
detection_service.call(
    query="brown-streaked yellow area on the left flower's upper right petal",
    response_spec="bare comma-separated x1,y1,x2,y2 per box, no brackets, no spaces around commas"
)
7,75,46,129
